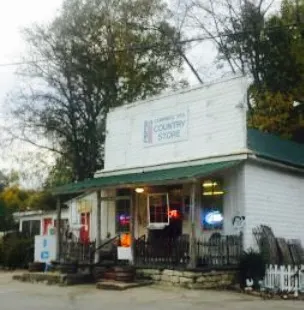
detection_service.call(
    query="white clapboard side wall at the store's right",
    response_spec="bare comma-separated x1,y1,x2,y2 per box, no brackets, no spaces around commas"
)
244,162,304,249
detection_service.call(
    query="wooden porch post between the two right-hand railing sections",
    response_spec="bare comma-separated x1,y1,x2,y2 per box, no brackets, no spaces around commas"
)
188,181,198,268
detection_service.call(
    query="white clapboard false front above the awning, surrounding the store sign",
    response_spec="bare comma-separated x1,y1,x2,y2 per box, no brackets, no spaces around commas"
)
103,78,246,171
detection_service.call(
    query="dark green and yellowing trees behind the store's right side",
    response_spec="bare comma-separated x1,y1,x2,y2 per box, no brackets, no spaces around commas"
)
191,0,304,142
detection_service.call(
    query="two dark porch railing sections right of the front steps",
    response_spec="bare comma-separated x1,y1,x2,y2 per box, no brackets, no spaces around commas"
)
134,234,242,268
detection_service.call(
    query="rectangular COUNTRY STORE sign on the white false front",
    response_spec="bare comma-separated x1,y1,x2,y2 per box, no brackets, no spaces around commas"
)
144,110,188,146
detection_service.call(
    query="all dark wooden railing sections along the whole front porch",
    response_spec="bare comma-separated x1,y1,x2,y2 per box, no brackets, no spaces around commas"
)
60,233,242,269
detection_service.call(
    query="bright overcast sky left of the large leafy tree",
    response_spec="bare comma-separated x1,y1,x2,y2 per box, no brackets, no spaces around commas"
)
0,0,62,180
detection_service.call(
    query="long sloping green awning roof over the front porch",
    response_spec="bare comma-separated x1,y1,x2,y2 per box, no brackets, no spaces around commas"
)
53,160,240,195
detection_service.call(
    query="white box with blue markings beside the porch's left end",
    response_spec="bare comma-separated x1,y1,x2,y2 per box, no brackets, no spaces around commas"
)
35,235,56,263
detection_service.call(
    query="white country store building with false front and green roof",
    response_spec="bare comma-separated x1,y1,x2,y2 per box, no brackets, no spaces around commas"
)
55,78,304,267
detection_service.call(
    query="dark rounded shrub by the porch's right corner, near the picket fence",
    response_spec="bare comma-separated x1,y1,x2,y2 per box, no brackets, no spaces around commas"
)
239,250,266,289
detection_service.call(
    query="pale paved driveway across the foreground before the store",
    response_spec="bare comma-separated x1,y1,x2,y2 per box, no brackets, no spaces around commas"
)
0,273,304,310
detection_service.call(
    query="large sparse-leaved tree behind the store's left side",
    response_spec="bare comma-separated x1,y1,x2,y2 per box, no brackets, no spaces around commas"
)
13,0,183,180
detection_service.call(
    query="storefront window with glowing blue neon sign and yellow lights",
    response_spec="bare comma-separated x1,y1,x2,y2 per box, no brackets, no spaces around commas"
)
201,180,224,230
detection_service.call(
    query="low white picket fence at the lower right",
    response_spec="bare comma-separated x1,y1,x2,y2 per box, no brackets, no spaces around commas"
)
264,265,304,293
